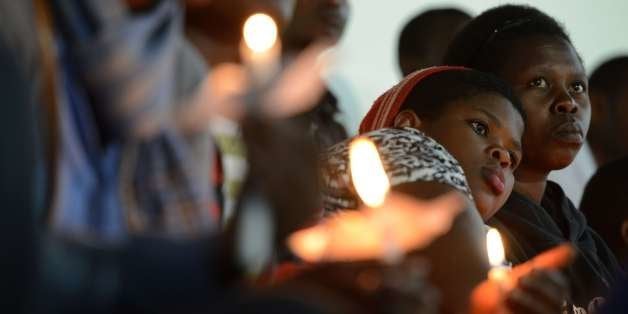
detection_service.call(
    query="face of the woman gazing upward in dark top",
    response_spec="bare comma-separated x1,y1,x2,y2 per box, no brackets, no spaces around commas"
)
498,36,591,178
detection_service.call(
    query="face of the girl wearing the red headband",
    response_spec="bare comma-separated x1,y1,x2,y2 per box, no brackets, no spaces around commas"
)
419,93,524,220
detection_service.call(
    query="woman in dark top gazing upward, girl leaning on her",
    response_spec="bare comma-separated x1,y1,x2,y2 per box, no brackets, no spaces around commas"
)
445,5,620,311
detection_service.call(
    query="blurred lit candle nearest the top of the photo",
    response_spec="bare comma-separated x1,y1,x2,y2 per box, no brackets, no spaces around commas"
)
240,13,281,88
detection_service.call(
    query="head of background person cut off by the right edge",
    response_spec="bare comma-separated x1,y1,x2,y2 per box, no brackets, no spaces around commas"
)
587,56,628,166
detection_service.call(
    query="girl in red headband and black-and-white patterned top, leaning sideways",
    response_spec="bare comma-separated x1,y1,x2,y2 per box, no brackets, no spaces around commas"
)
323,67,565,313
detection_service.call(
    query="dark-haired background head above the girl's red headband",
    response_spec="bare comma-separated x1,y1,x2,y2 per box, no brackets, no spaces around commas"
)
397,8,471,75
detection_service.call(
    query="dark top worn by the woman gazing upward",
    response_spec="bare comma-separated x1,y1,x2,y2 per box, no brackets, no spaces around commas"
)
488,181,621,309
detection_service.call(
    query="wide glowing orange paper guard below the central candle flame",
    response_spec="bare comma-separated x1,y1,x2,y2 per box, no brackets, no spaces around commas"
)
288,193,464,263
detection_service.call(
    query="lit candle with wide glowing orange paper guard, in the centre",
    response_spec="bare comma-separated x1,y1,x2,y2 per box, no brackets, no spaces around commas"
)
288,138,464,264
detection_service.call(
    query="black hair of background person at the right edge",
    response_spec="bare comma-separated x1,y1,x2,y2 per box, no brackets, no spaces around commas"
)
589,56,628,98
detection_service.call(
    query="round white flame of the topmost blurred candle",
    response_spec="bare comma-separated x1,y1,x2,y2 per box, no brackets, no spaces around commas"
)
242,13,277,53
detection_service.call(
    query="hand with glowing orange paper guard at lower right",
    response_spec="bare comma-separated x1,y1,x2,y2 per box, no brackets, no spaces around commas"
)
470,244,575,314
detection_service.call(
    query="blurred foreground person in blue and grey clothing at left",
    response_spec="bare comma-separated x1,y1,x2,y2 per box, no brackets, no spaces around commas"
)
0,0,221,313
